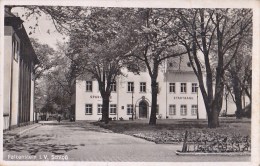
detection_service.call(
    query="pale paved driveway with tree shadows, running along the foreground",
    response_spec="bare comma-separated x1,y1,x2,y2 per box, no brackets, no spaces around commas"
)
1,122,250,162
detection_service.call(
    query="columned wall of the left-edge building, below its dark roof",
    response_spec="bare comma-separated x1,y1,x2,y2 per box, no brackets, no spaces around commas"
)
3,22,34,129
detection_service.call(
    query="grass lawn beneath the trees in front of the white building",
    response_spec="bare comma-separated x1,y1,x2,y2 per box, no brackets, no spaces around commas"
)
93,118,251,142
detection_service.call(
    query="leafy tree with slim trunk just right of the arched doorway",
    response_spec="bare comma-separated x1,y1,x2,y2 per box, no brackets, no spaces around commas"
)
131,9,187,125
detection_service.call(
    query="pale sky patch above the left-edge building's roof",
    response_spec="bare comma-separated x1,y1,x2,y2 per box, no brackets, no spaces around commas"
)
12,7,68,50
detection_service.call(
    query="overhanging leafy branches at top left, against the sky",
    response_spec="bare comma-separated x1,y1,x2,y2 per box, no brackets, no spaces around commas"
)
5,5,91,34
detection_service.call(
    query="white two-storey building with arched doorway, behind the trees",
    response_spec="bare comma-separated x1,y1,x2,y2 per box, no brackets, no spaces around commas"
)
75,55,206,120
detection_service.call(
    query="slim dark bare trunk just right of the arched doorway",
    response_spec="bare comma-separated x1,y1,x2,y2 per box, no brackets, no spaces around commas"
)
149,79,158,125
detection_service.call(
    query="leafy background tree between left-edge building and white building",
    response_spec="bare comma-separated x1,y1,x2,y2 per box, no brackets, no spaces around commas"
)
31,39,74,117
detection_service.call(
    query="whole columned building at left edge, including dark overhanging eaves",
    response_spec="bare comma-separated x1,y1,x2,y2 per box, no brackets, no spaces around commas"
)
2,8,38,130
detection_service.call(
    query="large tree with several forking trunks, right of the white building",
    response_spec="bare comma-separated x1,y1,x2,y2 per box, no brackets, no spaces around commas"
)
173,9,252,128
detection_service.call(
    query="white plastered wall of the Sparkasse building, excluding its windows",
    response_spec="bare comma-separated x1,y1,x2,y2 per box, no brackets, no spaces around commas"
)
75,70,206,120
